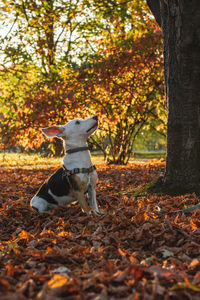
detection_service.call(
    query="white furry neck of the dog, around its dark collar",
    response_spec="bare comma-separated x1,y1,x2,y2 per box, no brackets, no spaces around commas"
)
63,141,92,170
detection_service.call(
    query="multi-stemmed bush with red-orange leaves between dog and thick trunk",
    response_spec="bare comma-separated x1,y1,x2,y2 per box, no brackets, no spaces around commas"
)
76,28,165,164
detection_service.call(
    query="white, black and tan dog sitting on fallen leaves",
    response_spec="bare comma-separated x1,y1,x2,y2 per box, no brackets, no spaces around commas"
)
30,116,101,214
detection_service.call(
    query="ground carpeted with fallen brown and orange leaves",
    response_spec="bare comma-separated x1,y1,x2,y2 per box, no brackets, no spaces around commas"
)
0,161,200,300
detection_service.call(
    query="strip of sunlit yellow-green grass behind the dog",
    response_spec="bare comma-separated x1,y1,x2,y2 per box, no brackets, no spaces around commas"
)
0,152,165,167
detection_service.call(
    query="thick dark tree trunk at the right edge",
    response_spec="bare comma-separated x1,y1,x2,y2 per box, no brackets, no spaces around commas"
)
147,0,200,193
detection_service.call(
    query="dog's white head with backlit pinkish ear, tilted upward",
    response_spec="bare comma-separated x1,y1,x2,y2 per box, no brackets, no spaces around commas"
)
42,116,98,141
